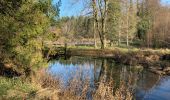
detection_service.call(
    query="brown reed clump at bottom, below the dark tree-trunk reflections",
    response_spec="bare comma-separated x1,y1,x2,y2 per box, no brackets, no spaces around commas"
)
93,78,133,100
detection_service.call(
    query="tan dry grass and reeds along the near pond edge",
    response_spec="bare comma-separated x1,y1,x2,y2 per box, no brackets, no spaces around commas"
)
28,71,133,100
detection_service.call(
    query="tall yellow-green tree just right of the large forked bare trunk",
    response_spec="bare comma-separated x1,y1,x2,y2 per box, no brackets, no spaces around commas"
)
107,0,122,44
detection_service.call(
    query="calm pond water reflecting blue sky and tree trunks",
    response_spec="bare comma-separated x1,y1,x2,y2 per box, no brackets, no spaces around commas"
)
48,57,170,100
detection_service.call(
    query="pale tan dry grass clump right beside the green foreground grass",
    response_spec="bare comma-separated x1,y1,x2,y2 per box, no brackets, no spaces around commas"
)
31,70,60,100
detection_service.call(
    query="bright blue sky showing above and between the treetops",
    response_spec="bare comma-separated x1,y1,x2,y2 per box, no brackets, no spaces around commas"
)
54,0,170,17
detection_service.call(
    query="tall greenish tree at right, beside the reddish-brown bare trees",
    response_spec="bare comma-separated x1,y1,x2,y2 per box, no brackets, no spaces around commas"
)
138,0,161,47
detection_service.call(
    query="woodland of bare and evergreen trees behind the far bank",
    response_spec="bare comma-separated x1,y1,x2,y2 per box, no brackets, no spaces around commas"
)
55,0,169,48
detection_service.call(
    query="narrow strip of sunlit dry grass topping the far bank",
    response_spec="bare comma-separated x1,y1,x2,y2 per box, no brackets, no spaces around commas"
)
67,48,170,58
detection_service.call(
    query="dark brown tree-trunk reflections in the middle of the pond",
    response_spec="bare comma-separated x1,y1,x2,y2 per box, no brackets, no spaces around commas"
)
94,59,141,94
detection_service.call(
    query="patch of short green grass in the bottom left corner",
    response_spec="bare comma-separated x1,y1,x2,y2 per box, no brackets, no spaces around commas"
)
0,77,37,100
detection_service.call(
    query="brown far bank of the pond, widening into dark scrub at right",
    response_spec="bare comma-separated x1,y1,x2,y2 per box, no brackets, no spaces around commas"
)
64,48,170,75
